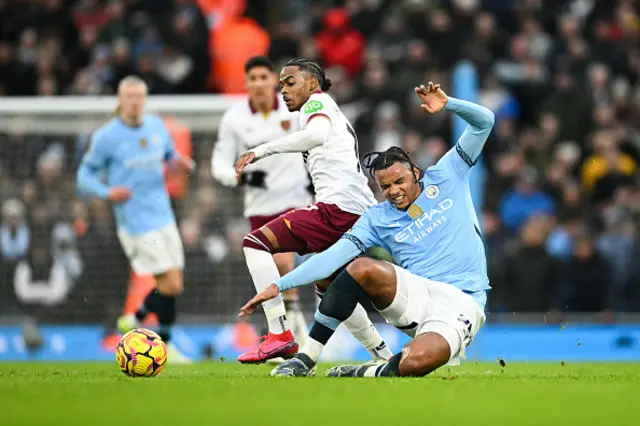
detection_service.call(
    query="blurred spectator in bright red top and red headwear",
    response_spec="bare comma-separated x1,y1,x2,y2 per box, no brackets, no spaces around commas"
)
316,8,365,77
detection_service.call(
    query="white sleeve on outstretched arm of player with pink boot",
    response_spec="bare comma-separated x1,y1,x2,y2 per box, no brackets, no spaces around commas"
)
251,115,331,160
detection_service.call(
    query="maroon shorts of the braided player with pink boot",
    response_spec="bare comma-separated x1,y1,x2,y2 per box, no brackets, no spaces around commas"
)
258,203,360,255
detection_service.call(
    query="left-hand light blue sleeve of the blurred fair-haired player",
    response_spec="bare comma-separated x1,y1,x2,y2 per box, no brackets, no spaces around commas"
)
76,132,109,199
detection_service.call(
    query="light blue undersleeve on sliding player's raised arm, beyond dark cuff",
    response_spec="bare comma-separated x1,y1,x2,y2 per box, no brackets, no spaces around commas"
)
444,97,495,166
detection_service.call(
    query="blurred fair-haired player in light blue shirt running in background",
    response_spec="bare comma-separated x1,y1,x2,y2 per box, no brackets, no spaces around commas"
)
77,76,193,363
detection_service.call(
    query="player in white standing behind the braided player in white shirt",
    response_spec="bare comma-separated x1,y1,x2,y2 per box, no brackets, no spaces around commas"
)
211,56,312,348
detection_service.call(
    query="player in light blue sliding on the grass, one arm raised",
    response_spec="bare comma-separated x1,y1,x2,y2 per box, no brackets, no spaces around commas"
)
240,83,494,377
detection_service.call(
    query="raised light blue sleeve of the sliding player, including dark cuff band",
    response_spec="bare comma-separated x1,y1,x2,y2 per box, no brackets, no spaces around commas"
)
439,97,495,178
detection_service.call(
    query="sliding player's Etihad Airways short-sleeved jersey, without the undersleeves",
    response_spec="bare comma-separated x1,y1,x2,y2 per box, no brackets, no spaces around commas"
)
343,145,491,302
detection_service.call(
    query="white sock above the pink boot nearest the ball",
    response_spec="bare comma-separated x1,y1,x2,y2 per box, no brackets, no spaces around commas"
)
244,247,289,334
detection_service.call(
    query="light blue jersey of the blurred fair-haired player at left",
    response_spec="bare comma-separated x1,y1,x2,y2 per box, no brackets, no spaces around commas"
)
77,115,177,235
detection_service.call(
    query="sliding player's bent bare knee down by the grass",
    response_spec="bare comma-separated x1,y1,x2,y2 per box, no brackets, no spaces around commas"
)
400,332,451,377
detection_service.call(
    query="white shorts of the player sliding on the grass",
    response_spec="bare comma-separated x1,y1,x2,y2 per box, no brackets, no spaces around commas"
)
380,265,486,365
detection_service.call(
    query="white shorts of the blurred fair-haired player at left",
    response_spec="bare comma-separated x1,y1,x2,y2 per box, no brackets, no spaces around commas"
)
118,223,184,275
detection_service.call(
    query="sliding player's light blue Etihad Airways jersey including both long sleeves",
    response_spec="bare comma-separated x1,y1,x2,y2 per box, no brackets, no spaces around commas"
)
276,98,494,308
